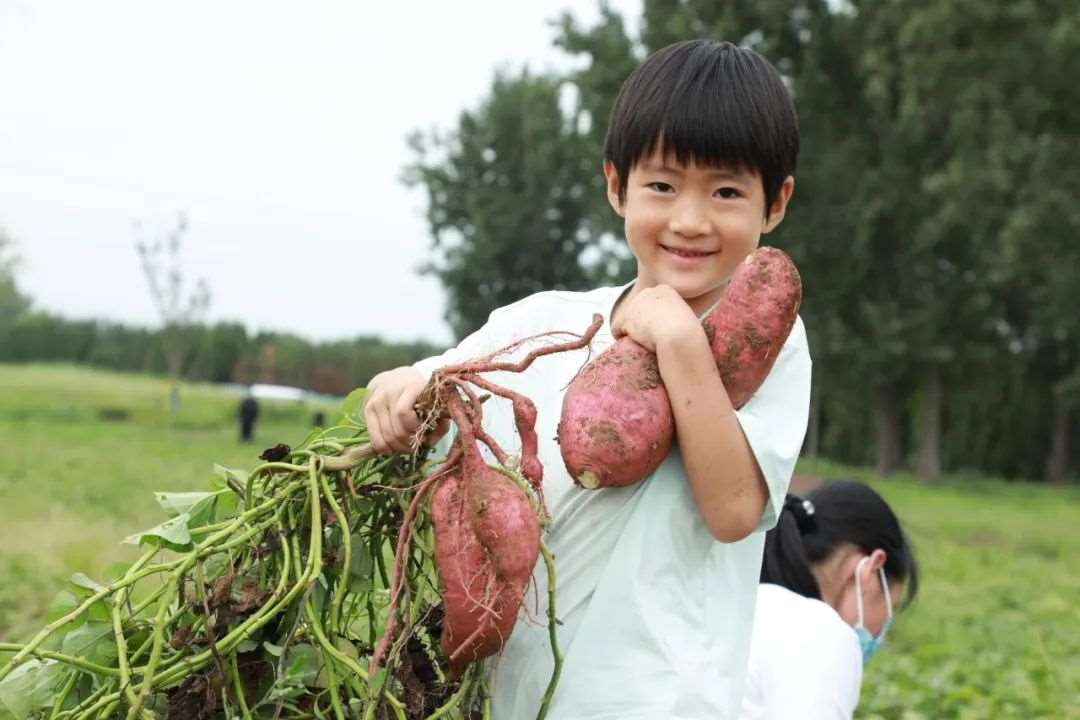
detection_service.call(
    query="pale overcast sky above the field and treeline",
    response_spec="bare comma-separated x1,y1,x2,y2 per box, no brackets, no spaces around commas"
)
0,0,640,342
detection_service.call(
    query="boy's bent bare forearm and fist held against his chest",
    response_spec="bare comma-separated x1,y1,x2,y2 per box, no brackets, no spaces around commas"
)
615,285,807,542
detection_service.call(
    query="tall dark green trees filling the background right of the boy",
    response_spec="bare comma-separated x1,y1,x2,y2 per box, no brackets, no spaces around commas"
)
406,0,1080,480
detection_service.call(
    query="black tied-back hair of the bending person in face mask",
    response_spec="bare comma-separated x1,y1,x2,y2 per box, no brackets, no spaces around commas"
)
761,480,919,606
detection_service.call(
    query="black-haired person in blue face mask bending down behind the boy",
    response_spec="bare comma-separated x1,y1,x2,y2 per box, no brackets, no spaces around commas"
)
740,480,919,720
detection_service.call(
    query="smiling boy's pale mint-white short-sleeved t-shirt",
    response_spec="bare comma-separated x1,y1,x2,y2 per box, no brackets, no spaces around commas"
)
416,286,810,720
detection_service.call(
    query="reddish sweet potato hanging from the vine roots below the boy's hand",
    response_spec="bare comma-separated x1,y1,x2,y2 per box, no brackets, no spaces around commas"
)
431,446,540,677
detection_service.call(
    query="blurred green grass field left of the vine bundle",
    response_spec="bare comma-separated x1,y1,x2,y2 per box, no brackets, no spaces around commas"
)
0,365,338,640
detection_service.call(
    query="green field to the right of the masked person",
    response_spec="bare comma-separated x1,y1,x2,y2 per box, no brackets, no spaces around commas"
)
802,463,1080,720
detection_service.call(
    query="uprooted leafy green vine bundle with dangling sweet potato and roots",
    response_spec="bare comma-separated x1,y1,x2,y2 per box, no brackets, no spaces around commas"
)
0,316,600,720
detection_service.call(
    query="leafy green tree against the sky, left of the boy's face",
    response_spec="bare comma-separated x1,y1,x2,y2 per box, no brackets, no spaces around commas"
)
405,69,599,338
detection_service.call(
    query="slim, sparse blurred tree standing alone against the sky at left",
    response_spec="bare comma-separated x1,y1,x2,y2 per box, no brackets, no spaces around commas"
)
135,213,210,381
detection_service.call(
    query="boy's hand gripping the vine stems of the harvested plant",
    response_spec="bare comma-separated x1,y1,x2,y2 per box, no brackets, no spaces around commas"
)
364,365,448,454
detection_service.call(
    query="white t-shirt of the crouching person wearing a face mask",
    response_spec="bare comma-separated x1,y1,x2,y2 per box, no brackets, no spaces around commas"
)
739,583,863,720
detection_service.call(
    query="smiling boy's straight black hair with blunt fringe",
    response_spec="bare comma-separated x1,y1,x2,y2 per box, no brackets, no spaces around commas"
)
604,40,799,216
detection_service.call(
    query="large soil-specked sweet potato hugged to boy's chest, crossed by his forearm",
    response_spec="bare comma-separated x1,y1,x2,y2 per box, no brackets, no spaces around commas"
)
558,247,802,489
